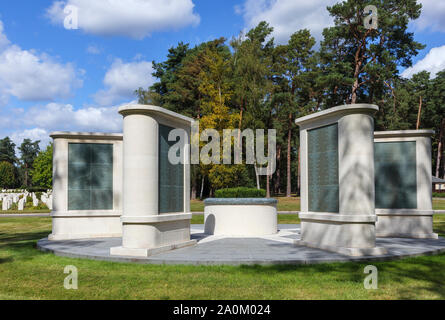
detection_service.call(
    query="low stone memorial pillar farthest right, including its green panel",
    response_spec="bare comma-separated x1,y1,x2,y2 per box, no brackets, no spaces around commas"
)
374,130,438,239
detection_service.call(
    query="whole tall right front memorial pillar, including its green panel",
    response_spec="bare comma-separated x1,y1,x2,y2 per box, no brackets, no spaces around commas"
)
296,104,386,256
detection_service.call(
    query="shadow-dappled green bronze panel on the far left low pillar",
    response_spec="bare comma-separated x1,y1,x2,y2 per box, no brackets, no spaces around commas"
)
68,143,113,211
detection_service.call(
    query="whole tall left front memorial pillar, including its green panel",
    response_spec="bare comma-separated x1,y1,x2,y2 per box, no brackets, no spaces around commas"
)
110,105,196,257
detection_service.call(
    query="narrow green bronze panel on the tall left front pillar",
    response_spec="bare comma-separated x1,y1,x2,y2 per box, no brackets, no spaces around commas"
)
159,125,184,213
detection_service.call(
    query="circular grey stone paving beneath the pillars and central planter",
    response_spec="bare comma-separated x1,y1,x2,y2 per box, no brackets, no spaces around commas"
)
37,225,445,265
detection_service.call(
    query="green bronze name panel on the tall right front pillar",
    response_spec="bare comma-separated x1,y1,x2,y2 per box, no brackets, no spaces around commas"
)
308,123,339,213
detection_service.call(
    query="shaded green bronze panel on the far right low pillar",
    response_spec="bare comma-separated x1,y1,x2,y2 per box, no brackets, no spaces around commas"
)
375,141,417,209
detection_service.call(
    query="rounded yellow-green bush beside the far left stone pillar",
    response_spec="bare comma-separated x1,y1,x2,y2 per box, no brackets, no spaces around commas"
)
31,144,53,191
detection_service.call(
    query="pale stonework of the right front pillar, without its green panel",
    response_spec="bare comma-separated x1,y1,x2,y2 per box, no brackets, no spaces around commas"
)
296,104,386,256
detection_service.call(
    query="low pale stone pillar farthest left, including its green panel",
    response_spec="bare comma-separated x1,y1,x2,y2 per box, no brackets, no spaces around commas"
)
48,132,122,240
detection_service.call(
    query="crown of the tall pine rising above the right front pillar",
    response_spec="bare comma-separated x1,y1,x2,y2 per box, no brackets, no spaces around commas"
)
320,0,425,106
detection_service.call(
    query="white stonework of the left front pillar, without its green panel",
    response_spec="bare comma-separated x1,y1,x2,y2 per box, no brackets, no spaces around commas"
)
110,105,196,257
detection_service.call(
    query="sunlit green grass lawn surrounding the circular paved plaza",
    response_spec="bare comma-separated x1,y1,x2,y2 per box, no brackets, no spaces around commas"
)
0,216,445,300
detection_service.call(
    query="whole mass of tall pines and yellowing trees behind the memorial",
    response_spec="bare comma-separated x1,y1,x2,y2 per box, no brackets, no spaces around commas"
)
136,0,445,197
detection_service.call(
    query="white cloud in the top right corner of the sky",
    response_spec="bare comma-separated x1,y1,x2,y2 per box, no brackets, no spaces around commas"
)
413,0,445,32
